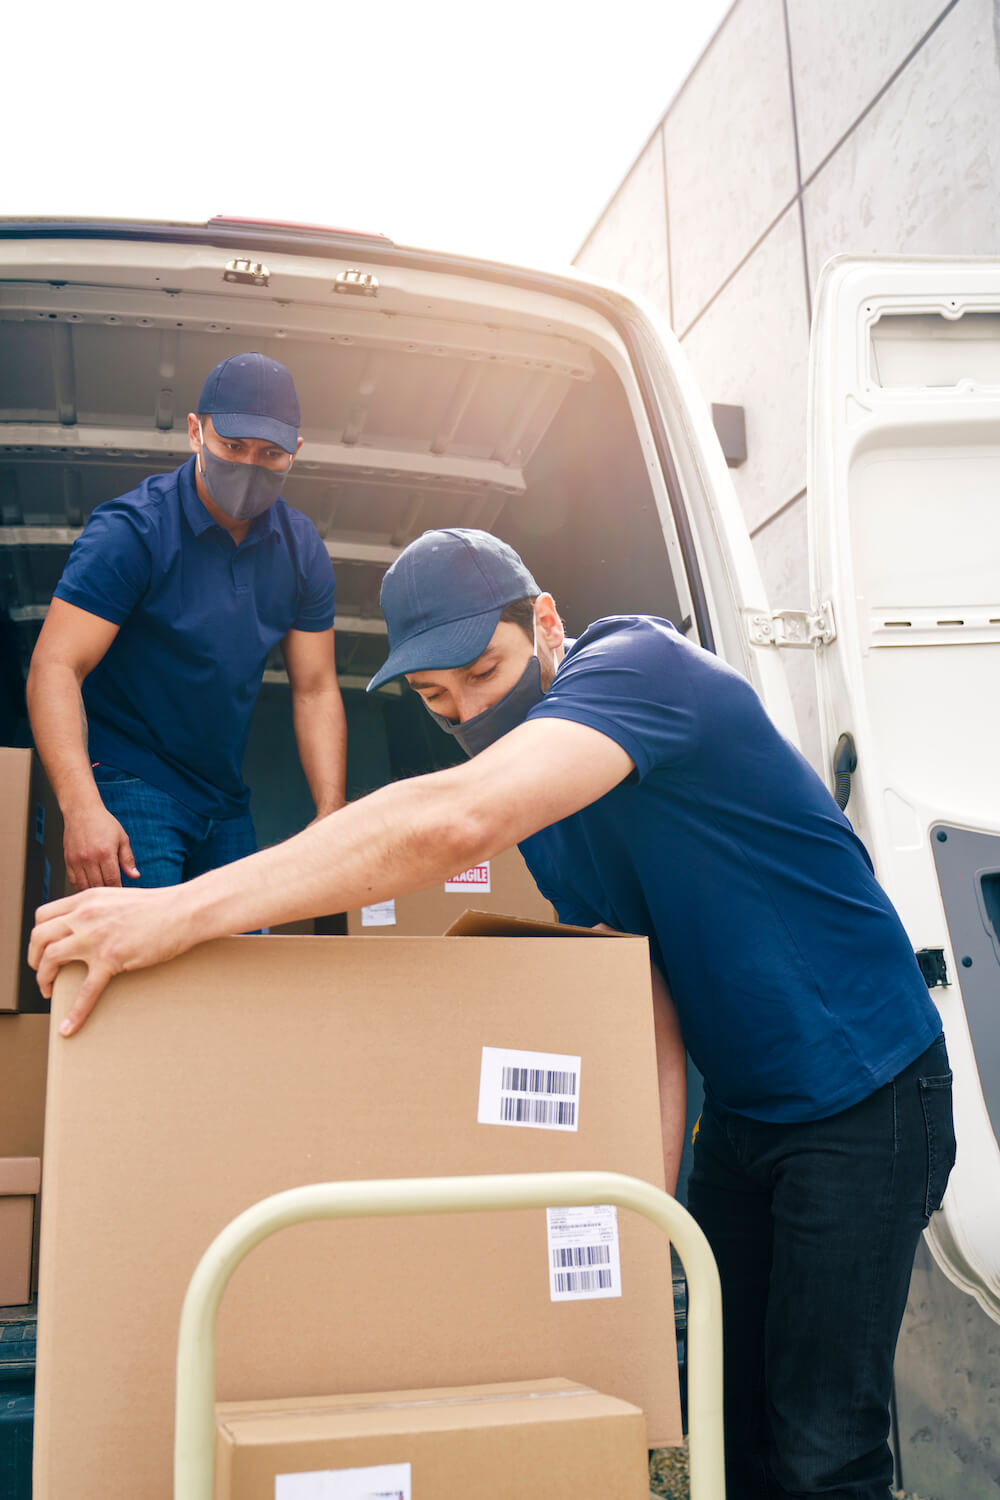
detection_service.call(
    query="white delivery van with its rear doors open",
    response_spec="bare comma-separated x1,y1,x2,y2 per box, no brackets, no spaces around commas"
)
0,219,1000,1320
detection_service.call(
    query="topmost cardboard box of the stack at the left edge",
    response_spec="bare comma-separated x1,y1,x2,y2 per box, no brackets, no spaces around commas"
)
0,746,66,1013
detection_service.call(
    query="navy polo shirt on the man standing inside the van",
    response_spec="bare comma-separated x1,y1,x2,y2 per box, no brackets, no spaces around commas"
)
55,458,334,818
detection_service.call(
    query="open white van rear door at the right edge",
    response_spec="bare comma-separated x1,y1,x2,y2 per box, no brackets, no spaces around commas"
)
808,258,1000,1320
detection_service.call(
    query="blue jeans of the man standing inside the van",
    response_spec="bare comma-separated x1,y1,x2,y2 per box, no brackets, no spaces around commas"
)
94,764,256,887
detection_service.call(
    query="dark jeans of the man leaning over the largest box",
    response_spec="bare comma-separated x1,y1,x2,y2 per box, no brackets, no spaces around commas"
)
688,1037,955,1500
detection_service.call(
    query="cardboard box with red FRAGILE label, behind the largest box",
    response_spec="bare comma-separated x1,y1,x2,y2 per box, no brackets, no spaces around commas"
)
348,849,555,938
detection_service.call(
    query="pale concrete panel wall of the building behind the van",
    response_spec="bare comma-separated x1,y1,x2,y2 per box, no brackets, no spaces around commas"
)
576,0,1000,1500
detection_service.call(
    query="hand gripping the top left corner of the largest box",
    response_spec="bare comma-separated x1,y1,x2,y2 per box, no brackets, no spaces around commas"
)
28,887,189,1037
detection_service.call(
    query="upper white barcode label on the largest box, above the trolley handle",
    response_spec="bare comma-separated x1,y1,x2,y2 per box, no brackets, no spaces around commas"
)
477,1047,580,1131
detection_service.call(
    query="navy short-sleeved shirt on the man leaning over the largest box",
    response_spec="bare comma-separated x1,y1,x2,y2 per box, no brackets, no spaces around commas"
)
520,615,940,1121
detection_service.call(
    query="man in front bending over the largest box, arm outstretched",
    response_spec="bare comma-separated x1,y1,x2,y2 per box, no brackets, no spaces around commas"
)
30,530,955,1500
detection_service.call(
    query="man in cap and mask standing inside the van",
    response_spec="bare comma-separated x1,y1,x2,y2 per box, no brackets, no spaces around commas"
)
27,354,346,890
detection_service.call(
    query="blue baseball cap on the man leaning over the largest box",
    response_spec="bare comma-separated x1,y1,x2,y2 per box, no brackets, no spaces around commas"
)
367,527,540,693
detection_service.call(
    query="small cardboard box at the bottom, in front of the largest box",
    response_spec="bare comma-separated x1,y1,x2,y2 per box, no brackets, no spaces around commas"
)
216,1380,649,1500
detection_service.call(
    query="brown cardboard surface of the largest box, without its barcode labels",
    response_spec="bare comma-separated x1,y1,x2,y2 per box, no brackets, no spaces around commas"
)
34,938,679,1500
